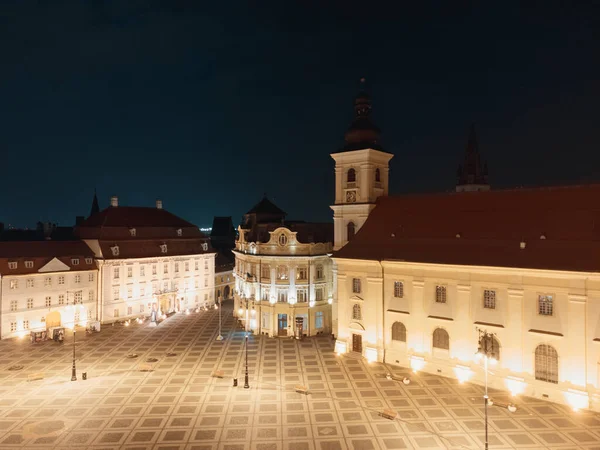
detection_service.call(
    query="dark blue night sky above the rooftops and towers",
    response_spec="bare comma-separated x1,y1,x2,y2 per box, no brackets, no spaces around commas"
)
0,0,600,226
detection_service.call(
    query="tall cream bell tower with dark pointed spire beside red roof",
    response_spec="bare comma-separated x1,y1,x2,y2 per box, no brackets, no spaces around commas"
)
331,78,394,251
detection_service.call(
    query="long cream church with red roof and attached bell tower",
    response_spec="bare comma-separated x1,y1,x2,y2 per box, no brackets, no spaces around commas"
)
331,86,600,411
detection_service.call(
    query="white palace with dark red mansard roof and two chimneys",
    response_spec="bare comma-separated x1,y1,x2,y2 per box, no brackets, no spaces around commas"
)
77,197,215,322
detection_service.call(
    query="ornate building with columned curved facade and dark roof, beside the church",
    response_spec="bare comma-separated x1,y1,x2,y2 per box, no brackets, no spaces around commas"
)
234,196,334,337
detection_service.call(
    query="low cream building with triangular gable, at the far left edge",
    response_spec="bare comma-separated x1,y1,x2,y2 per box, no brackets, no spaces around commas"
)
0,241,98,339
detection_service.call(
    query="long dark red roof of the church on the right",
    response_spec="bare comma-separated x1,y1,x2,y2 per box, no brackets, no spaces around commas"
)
334,185,600,272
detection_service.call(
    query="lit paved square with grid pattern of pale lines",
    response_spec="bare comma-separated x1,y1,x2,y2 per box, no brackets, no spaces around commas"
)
0,305,600,450
